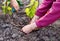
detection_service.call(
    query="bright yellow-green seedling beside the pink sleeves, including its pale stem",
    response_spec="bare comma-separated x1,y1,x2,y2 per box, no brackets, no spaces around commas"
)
25,0,39,18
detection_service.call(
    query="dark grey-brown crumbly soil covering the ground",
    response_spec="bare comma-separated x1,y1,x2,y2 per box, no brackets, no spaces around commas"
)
0,0,60,41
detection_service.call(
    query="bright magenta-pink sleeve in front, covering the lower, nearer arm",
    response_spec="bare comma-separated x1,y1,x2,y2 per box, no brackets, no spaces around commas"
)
36,2,60,27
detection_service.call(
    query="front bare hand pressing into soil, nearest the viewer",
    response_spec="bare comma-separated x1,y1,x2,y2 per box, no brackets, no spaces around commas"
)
22,23,37,34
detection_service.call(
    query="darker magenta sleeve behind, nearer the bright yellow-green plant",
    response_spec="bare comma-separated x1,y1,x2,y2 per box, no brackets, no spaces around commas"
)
36,0,55,17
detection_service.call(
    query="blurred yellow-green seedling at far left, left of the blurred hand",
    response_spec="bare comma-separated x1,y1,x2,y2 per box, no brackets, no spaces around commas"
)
2,0,12,15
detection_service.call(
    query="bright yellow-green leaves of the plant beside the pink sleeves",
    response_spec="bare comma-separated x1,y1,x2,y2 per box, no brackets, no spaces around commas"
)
25,0,38,18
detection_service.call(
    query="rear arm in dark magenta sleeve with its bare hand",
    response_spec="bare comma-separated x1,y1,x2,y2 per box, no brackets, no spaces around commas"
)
31,0,53,23
